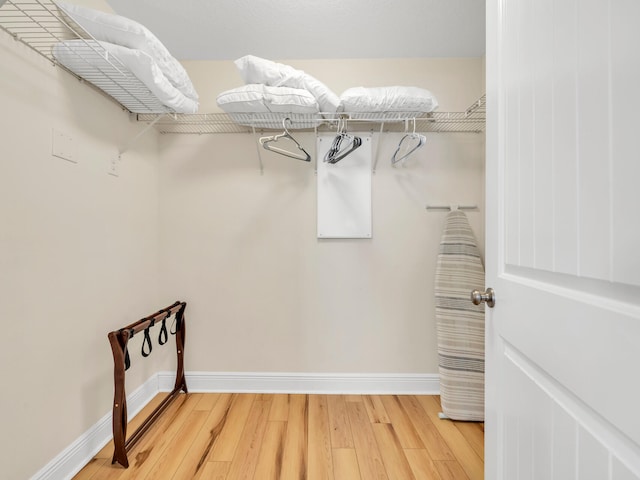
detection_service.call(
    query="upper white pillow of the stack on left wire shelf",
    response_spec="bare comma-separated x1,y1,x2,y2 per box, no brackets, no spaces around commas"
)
56,1,198,101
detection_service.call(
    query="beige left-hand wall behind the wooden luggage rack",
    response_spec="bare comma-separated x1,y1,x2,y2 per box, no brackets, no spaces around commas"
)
0,34,168,479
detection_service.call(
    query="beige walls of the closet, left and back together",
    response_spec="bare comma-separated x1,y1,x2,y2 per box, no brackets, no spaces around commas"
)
0,29,484,478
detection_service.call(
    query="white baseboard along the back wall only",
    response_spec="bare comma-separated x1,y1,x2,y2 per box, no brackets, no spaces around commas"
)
158,372,440,395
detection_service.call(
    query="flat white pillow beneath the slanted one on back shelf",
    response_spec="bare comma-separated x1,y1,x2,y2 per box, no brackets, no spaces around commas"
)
216,84,318,113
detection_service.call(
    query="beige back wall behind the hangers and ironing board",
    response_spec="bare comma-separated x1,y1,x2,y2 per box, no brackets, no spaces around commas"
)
160,59,484,373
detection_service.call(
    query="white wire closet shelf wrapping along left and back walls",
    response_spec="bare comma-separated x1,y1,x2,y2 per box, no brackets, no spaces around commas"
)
0,0,486,134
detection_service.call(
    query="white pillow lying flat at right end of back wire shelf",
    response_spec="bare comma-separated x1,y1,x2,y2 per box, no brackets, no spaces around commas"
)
339,86,438,114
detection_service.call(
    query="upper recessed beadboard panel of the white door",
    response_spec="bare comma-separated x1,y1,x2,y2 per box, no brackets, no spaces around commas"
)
503,0,640,286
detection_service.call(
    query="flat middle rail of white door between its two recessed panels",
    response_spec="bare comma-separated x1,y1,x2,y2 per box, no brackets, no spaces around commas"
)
496,274,640,444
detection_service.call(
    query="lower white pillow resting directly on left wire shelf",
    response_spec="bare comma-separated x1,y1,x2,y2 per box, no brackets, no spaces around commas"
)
53,40,198,113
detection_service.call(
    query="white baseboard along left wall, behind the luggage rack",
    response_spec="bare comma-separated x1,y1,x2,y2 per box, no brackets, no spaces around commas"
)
31,374,159,480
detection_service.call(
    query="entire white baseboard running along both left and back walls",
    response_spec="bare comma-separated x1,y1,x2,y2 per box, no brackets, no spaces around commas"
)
31,372,440,480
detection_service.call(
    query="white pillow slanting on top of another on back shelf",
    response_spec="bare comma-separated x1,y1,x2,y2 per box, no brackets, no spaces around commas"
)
235,55,340,113
